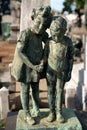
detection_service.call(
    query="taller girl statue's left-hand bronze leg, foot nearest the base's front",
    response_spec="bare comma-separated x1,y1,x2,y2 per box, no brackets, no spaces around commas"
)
20,83,35,125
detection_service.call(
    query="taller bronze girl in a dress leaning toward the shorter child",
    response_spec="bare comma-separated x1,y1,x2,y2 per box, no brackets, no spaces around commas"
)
11,6,52,125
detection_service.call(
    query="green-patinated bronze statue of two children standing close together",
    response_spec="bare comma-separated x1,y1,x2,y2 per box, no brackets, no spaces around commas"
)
11,6,73,125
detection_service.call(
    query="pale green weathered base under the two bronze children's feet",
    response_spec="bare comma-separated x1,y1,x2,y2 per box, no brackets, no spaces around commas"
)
16,108,82,130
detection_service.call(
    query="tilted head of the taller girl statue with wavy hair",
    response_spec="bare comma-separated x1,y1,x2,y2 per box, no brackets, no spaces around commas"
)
31,6,52,34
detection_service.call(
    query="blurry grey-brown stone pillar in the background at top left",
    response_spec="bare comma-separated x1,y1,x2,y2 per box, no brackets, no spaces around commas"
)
8,0,21,43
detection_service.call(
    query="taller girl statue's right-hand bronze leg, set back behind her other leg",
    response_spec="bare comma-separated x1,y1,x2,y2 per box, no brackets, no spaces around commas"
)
31,82,40,116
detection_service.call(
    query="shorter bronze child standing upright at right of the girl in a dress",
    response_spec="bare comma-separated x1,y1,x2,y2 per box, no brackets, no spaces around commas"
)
44,16,73,123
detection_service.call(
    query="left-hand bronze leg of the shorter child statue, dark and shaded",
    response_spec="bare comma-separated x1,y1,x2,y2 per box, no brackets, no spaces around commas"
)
47,79,56,122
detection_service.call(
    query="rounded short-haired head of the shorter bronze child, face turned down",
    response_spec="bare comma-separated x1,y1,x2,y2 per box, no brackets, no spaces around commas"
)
50,16,67,42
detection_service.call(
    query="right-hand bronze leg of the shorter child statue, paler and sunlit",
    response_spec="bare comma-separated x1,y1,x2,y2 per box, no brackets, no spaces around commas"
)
56,79,65,123
